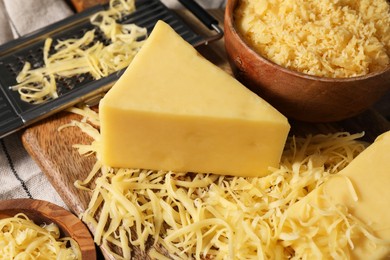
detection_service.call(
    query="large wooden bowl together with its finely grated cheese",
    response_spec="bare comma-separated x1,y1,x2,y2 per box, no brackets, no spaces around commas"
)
224,0,390,122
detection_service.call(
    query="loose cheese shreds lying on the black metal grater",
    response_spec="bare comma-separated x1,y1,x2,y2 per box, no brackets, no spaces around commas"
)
11,0,147,104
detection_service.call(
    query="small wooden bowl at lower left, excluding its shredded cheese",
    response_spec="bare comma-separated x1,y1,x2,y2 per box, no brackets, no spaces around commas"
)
0,199,96,260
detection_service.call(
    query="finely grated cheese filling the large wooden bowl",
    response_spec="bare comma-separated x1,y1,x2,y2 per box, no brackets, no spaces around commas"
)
234,0,390,78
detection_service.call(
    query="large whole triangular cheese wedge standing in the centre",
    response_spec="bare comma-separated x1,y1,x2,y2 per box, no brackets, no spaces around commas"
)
99,21,290,176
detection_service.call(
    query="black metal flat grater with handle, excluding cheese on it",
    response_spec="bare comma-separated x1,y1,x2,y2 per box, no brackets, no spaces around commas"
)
0,0,223,138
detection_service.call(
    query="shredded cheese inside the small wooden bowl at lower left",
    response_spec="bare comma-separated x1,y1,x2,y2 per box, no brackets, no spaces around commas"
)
0,213,81,260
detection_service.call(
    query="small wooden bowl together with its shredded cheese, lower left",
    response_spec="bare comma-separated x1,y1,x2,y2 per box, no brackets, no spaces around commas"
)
0,199,96,260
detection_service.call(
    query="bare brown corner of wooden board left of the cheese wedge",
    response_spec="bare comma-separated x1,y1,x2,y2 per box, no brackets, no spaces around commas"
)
22,112,95,214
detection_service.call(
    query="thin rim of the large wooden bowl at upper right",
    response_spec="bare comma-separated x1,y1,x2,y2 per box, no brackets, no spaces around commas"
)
224,0,390,83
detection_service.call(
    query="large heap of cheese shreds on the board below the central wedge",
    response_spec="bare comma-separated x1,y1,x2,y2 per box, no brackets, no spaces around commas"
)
61,106,388,259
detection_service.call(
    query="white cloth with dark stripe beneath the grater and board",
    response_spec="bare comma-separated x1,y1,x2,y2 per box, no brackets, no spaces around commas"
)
0,0,225,208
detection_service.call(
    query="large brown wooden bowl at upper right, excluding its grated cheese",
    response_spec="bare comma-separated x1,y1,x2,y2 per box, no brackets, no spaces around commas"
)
224,0,390,122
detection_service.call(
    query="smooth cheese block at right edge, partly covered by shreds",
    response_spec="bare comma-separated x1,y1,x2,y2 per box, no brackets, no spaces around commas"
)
287,131,390,260
